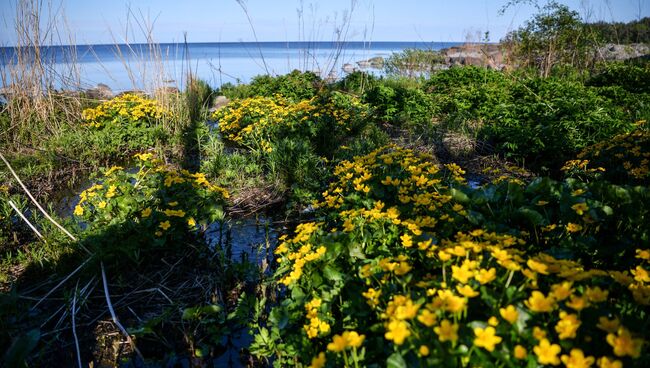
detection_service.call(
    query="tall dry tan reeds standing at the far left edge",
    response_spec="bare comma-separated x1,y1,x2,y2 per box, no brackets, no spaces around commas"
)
0,0,81,150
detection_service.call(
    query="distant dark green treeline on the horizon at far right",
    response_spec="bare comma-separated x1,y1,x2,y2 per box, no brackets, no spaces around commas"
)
587,17,650,44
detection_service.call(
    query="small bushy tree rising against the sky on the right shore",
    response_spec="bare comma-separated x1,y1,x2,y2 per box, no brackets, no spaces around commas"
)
505,1,592,77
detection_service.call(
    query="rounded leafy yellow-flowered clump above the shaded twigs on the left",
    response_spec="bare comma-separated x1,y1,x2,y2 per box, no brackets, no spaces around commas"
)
74,153,229,261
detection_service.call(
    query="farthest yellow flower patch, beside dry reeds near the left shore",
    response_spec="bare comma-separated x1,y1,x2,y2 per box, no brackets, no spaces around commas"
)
81,93,171,128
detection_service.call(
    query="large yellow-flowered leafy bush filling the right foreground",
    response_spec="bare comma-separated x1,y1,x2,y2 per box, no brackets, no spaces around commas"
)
251,147,650,367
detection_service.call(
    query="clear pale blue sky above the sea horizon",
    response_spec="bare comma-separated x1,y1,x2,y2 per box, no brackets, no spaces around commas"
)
0,0,650,46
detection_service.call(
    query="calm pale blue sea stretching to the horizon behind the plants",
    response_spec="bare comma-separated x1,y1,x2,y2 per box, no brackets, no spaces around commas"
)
0,42,460,91
